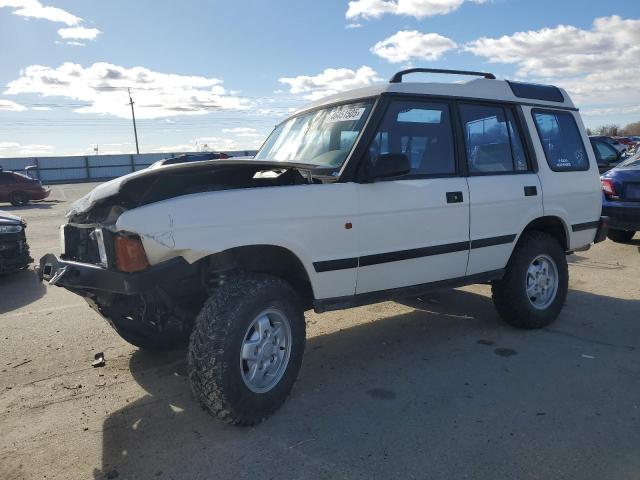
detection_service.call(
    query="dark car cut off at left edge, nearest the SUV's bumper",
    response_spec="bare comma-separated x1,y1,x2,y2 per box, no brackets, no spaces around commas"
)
0,210,33,275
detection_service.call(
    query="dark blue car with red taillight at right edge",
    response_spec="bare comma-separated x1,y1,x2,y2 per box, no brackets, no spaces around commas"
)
600,154,640,242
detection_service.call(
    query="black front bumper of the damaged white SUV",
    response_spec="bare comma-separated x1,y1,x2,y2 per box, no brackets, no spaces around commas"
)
36,253,194,295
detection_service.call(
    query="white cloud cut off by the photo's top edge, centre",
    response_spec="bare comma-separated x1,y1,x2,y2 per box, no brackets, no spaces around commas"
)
346,0,487,19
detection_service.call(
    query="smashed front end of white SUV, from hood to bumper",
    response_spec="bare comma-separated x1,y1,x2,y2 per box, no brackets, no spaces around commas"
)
37,160,316,349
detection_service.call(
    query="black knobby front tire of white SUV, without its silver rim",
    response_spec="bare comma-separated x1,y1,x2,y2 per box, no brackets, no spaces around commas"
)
188,274,306,425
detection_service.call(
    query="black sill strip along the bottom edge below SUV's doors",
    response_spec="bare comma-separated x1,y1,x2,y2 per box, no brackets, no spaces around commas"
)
313,269,504,313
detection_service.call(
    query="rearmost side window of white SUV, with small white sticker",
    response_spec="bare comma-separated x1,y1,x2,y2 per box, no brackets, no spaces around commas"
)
533,110,589,172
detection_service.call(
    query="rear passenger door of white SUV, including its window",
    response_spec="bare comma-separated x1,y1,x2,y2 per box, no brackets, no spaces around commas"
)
458,103,542,275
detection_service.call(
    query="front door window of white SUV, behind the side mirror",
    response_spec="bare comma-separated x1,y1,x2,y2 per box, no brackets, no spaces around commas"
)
369,100,456,176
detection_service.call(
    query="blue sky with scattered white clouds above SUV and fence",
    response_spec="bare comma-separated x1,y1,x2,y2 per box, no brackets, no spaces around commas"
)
0,0,640,157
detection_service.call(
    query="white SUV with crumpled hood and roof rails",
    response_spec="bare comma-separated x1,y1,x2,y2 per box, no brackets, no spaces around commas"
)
39,69,606,425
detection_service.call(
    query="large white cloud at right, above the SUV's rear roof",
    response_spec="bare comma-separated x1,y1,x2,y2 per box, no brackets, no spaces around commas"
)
464,16,640,106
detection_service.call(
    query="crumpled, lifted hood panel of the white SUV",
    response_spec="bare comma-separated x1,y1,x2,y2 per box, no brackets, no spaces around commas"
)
67,159,314,218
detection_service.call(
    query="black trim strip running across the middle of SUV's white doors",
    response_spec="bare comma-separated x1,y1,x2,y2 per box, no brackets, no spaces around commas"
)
313,236,516,273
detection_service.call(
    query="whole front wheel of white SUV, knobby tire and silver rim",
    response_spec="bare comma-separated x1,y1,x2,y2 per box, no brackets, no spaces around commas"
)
188,274,305,425
